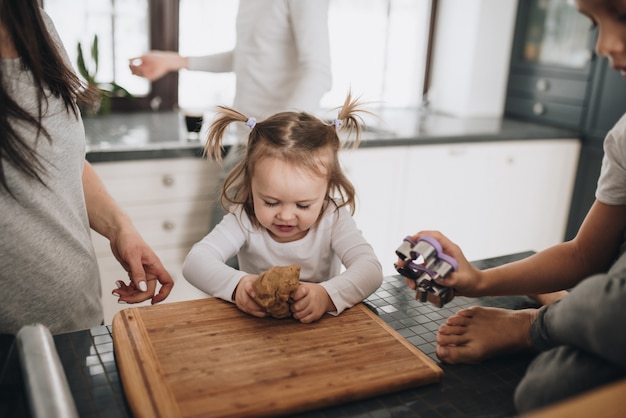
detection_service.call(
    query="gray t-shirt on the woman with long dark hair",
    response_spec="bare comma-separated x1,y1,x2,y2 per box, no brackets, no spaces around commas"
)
0,11,103,334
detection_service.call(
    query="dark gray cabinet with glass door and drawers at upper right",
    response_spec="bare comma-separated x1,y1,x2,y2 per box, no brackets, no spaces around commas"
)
505,0,626,239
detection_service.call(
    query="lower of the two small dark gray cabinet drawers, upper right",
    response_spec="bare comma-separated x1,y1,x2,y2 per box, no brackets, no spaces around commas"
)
505,96,584,129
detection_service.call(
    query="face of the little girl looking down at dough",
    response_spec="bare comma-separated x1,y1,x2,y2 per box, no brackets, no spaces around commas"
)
252,158,328,242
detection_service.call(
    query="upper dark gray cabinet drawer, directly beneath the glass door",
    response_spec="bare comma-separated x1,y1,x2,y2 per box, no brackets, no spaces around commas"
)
508,74,587,105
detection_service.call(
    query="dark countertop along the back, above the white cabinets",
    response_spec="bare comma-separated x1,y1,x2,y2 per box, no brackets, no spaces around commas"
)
84,109,579,162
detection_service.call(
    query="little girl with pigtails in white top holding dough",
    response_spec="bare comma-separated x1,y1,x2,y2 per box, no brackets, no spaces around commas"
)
183,95,382,323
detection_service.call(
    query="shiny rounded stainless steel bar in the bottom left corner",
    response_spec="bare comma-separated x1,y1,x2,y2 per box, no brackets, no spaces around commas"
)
16,324,78,418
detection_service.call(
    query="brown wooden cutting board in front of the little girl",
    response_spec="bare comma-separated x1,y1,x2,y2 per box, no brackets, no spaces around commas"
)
113,298,443,418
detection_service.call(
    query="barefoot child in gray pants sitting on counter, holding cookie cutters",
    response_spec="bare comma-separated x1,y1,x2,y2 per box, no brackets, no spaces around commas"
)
400,0,626,413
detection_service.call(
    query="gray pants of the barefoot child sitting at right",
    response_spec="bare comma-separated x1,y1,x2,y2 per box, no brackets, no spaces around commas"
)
515,253,626,413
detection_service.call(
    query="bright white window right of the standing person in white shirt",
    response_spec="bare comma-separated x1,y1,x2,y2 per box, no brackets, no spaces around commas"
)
322,0,430,107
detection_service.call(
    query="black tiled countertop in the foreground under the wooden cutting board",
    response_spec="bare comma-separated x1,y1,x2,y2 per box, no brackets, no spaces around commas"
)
0,252,536,418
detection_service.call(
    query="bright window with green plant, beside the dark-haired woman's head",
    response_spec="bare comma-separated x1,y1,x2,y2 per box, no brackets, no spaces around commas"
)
43,0,178,110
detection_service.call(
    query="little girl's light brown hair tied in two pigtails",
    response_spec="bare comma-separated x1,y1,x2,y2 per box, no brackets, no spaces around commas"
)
205,94,370,226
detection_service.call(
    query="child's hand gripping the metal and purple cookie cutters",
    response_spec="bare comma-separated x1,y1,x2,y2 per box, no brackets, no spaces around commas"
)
405,231,482,297
